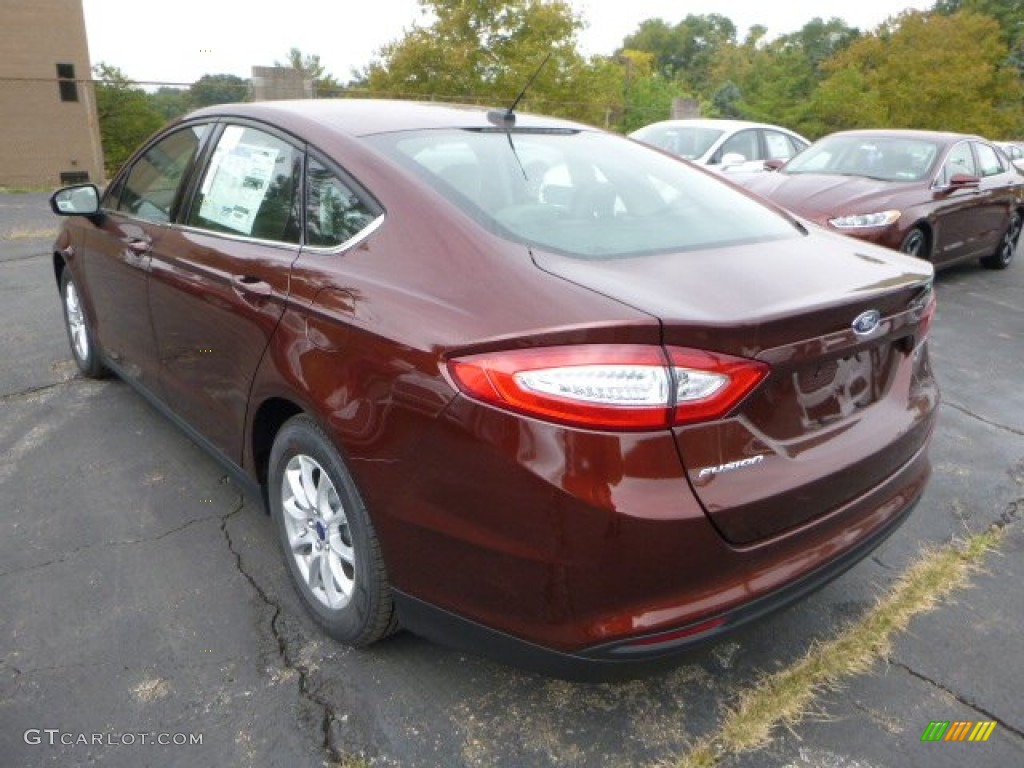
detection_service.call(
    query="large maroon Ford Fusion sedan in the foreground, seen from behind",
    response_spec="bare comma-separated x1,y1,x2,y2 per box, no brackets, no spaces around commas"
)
52,100,938,675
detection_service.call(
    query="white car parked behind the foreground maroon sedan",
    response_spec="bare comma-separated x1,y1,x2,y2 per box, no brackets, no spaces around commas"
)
630,120,811,173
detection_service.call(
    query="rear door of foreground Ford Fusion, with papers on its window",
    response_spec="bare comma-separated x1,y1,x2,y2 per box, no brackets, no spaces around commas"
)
150,123,304,462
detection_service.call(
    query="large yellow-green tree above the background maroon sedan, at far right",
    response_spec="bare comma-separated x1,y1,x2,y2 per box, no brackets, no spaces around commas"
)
812,11,1024,136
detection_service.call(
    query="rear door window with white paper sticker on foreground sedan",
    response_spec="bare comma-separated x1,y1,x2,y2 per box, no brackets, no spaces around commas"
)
188,125,302,243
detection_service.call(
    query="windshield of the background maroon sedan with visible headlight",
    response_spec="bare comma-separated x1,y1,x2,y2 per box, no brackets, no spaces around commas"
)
782,134,939,181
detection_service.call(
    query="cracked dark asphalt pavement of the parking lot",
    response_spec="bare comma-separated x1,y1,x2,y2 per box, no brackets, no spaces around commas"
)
0,195,1024,768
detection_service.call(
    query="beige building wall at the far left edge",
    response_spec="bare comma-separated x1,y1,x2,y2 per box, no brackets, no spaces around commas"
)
0,0,103,186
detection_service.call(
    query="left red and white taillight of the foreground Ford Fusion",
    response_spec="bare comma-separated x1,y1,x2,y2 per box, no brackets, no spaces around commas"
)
447,344,768,430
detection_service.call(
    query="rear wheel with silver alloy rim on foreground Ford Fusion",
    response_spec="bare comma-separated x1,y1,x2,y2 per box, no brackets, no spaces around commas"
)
267,416,397,646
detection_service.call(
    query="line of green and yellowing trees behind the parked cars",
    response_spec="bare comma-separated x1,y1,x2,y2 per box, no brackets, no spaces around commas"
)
95,0,1024,171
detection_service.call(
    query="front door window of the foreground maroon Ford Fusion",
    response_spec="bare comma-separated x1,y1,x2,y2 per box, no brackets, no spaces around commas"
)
112,125,208,224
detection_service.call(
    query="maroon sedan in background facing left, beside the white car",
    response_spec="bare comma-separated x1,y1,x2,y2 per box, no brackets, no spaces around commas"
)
740,130,1024,269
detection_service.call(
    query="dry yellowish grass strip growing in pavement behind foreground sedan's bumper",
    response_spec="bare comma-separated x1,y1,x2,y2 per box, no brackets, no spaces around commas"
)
668,526,1004,768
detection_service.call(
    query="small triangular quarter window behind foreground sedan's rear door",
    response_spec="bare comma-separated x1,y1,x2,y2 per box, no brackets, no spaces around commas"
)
306,158,378,247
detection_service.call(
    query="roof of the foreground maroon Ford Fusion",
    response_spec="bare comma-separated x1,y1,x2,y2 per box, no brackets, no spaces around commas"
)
186,98,596,136
